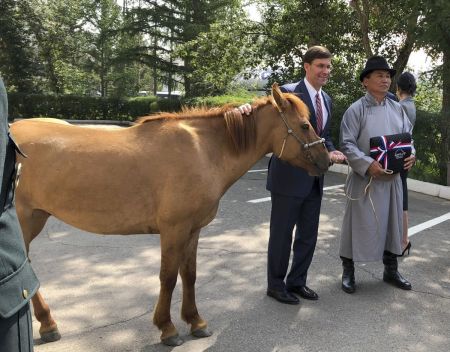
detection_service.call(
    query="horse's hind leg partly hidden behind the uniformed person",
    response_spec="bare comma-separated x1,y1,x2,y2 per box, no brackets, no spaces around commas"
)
17,208,61,342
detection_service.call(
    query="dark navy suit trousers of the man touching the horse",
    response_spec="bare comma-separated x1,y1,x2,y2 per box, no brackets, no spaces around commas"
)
267,178,322,291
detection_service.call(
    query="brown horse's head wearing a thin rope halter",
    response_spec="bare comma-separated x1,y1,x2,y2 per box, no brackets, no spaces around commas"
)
272,83,330,176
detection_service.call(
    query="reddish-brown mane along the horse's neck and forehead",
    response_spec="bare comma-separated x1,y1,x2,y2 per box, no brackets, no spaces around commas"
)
136,93,309,154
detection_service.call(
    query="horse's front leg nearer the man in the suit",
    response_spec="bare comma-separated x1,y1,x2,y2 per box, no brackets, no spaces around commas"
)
180,230,211,337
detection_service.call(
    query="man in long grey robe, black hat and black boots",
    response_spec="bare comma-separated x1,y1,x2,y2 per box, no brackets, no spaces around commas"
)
339,56,415,293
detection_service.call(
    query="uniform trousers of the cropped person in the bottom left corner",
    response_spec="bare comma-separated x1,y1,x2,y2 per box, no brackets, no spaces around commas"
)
0,304,33,352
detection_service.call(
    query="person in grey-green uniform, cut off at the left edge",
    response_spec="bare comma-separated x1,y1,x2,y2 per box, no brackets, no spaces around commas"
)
0,78,39,352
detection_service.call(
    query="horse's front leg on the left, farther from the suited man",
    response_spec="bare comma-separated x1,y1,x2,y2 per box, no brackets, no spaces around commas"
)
153,230,185,346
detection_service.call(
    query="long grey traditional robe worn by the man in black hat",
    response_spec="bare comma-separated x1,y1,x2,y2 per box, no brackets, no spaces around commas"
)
339,93,412,262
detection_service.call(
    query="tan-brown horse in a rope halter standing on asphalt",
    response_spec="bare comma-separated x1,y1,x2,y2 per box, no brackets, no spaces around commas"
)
11,85,329,345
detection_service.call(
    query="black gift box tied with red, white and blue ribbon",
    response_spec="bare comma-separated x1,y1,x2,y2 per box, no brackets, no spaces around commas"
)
370,133,412,174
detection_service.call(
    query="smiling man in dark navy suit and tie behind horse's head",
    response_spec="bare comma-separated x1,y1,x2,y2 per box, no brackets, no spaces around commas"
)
267,46,345,304
